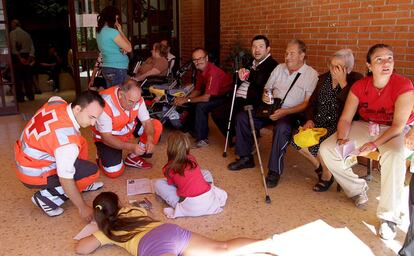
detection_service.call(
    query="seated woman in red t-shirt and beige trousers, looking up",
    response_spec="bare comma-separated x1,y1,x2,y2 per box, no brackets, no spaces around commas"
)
320,44,414,239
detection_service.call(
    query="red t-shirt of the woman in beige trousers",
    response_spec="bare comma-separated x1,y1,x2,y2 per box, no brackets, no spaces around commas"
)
351,74,414,125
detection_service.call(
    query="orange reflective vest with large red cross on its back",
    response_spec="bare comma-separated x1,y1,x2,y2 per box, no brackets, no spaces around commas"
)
14,100,83,185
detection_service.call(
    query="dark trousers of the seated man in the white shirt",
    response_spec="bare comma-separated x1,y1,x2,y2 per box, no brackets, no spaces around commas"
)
236,112,296,174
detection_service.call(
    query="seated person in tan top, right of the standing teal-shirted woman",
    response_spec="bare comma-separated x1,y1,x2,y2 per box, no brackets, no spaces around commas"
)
135,43,168,81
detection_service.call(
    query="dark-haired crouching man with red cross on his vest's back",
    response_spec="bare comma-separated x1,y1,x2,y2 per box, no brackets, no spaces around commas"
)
15,92,105,221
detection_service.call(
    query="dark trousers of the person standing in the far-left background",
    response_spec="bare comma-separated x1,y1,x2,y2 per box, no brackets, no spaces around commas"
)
12,54,34,102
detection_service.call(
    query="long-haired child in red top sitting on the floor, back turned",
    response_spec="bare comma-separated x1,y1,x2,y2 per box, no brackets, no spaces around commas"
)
154,131,227,218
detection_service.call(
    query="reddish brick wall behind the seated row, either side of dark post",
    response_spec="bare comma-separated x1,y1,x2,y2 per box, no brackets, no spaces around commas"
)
181,0,414,80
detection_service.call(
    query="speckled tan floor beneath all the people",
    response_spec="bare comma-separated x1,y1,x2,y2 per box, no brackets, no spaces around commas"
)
0,92,407,255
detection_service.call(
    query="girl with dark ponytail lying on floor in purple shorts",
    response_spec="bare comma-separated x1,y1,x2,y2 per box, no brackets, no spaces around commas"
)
75,192,274,256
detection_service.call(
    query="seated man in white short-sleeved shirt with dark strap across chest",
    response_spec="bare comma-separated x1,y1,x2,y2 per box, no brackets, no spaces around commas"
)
227,39,318,188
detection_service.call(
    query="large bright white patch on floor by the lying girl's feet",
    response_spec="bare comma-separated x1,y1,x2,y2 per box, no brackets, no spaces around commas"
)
273,220,374,256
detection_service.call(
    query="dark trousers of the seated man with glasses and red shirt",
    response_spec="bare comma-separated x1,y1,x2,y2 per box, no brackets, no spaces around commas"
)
194,97,226,141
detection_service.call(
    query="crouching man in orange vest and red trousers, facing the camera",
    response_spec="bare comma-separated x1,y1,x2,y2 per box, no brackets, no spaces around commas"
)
92,79,162,178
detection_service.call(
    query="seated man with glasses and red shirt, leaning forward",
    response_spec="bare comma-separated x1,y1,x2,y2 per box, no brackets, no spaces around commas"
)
174,48,233,148
